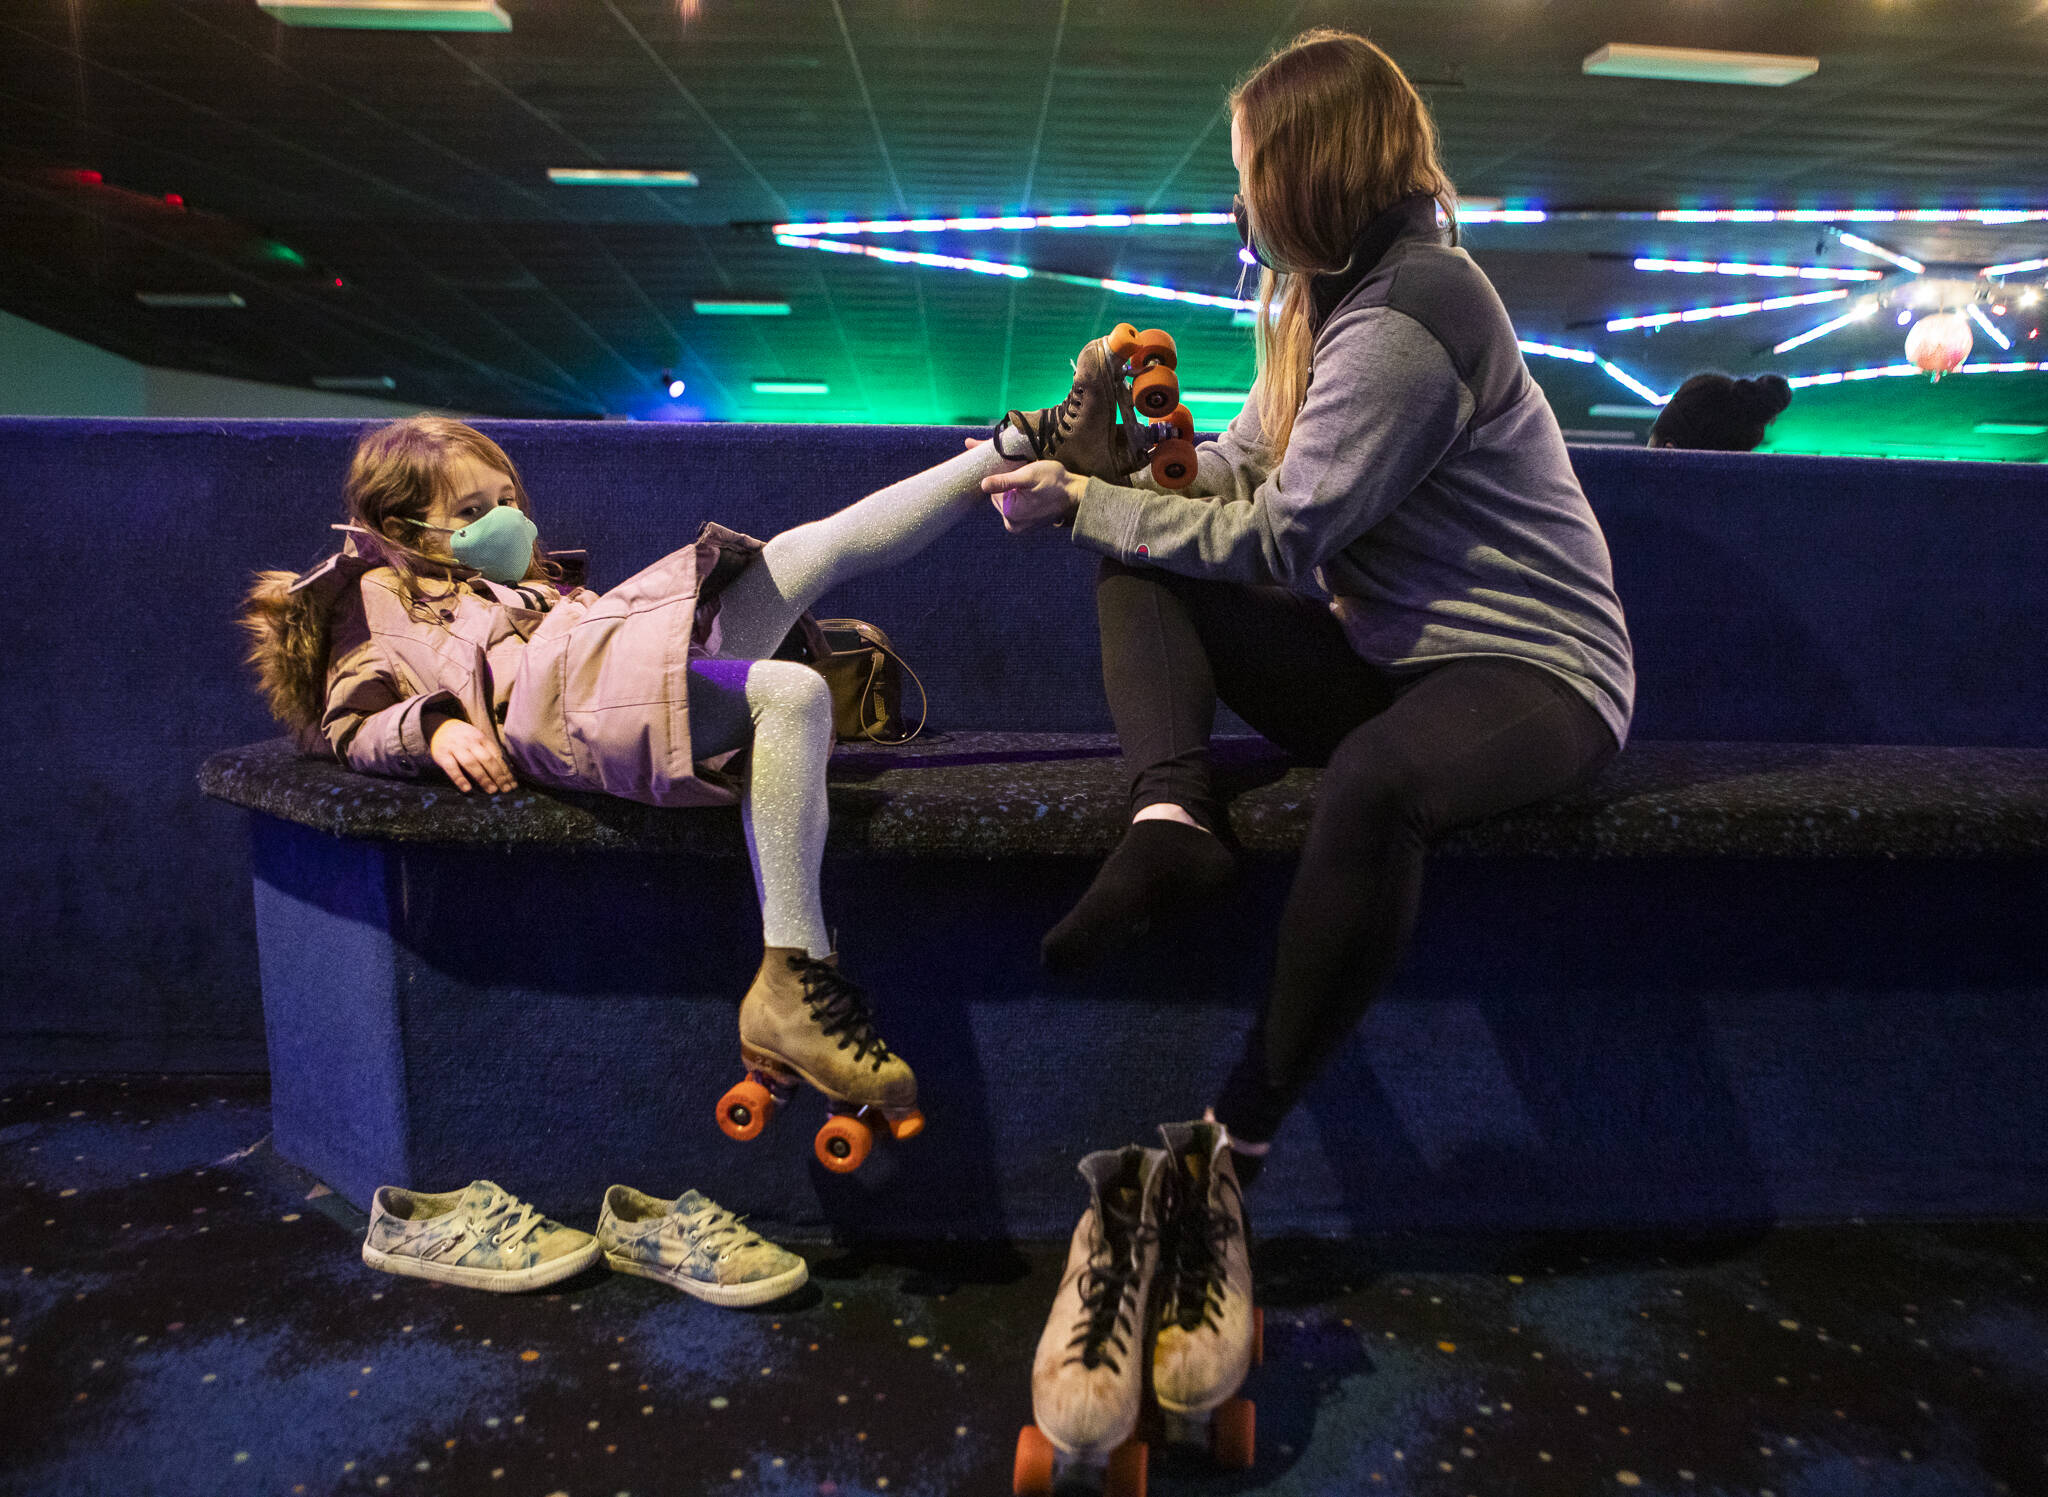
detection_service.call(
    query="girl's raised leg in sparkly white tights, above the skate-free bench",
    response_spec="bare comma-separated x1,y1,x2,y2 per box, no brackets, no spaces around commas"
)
719,442,1016,659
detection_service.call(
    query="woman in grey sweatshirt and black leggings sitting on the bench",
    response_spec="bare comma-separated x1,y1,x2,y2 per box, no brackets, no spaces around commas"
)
983,31,1634,1175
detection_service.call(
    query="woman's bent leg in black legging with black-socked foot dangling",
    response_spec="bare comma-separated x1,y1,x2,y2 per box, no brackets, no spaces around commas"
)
1040,561,1393,971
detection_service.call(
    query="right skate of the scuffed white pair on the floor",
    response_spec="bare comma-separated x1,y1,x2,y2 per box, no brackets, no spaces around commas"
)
1153,1122,1262,1470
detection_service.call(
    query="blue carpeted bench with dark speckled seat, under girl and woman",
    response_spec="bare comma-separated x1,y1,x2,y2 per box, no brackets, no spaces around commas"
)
201,733,2048,1235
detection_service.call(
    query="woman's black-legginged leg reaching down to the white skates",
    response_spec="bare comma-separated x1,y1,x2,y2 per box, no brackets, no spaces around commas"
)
1214,657,1614,1143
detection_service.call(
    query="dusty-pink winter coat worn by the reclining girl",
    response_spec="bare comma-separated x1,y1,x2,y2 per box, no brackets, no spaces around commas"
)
301,524,762,807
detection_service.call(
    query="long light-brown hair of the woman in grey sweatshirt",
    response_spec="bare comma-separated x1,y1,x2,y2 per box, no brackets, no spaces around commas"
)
1231,29,1458,463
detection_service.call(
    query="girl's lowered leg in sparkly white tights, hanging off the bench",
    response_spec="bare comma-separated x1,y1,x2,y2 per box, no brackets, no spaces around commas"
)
690,659,831,958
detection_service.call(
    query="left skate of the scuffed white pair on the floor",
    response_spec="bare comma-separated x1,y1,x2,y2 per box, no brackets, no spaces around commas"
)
1014,1145,1171,1497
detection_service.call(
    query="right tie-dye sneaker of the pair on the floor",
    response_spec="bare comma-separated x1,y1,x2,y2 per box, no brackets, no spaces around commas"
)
598,1186,811,1307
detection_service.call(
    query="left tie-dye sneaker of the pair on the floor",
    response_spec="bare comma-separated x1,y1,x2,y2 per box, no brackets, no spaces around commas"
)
362,1180,598,1294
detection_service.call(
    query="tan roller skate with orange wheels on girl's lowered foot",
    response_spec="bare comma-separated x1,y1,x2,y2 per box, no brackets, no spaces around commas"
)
719,946,924,1175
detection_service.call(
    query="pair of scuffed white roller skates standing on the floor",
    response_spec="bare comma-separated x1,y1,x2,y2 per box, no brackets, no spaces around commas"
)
1012,1122,1264,1497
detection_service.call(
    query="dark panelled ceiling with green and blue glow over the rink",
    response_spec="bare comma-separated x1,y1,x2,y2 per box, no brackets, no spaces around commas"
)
0,0,2048,455
